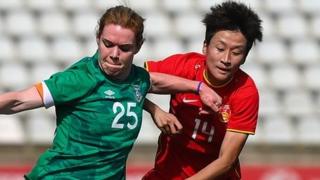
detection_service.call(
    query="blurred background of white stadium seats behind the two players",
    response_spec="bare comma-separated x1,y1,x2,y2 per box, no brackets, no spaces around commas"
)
0,0,320,180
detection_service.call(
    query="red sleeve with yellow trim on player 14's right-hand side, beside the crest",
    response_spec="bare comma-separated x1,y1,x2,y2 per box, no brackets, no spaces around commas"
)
227,86,259,134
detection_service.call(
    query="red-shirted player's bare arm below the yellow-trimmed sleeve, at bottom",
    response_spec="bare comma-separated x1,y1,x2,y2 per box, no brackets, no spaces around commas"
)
188,131,248,180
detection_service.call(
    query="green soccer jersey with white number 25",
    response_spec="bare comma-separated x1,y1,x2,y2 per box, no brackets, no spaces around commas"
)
26,53,150,180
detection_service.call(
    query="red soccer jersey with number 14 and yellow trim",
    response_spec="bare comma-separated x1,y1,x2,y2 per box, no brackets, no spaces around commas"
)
145,53,259,180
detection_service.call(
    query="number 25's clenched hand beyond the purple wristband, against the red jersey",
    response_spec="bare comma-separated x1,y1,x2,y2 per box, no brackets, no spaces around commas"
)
199,83,222,114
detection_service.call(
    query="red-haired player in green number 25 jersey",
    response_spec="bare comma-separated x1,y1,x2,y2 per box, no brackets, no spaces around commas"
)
0,6,220,180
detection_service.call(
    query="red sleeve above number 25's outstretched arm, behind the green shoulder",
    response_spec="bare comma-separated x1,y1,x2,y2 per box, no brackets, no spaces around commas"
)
145,53,201,79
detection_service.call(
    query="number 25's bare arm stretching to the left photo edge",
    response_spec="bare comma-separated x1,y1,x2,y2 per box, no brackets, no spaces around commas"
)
0,87,44,114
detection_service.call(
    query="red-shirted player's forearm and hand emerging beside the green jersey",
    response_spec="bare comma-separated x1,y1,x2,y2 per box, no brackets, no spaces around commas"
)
143,99,182,134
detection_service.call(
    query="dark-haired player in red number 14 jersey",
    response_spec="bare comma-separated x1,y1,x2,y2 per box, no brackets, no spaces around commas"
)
143,1,262,180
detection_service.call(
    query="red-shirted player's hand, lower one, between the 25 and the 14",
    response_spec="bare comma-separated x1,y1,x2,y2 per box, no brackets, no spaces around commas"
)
152,108,182,134
